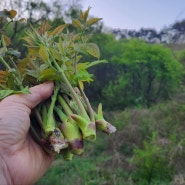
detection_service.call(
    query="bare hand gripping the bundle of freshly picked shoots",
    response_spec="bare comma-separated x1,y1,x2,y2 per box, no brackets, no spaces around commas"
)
0,82,53,185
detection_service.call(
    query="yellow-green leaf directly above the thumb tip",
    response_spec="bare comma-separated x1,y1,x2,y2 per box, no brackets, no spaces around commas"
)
38,68,60,81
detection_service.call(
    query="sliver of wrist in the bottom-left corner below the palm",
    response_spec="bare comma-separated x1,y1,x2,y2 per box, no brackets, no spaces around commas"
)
0,157,13,185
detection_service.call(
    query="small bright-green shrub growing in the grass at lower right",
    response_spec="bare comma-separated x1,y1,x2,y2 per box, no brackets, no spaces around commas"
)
132,132,173,185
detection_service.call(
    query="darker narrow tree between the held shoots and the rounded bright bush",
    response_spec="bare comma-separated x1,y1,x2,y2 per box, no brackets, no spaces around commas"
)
86,31,123,102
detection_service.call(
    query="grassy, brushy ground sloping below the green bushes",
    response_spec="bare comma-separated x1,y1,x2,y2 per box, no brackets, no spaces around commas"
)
36,90,185,185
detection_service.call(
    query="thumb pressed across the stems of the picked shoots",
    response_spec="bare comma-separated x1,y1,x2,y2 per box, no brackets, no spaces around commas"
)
3,82,54,109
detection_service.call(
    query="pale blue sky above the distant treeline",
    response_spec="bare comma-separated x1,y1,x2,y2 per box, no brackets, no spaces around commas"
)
81,0,185,31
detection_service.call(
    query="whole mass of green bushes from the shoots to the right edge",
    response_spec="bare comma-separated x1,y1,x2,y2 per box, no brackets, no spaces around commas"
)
85,34,183,110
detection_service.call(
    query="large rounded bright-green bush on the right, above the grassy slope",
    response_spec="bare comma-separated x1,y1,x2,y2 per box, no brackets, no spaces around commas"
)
103,39,183,108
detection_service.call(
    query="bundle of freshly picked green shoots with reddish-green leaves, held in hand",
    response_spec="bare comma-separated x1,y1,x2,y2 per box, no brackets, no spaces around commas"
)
0,9,116,160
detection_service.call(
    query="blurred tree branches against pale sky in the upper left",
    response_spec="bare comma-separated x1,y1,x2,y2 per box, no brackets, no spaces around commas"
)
0,0,81,41
